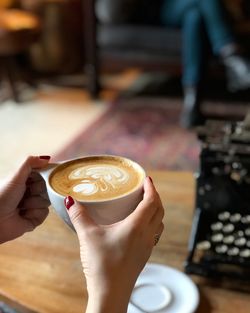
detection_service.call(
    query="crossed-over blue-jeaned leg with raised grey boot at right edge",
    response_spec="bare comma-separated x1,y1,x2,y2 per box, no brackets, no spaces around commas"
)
200,0,250,91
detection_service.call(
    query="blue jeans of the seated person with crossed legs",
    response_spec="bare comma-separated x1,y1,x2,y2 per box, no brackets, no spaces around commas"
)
161,0,235,86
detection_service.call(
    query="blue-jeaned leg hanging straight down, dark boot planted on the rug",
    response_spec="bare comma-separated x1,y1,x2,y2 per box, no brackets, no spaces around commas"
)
161,0,204,128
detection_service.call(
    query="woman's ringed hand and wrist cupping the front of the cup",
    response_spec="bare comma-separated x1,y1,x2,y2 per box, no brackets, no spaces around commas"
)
65,177,164,313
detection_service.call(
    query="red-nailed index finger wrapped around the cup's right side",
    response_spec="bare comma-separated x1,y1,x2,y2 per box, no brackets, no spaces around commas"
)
128,177,159,223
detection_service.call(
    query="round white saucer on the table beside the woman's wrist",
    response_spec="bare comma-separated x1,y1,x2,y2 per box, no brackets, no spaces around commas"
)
128,263,199,313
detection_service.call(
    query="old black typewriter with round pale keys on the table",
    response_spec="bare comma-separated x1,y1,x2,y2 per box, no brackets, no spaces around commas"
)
185,115,250,282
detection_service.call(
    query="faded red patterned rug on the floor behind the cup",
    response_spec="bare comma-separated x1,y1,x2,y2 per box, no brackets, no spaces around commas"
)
54,97,200,171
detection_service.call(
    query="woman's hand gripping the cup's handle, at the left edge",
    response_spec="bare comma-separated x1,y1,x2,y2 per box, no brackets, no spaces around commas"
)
0,156,50,243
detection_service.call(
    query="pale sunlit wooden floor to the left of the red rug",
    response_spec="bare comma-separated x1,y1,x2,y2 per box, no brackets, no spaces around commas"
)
0,70,141,180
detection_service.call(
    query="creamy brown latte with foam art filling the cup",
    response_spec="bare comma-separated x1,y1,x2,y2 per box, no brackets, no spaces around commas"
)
49,155,145,201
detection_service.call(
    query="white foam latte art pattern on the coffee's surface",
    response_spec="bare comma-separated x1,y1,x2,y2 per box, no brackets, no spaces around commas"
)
69,165,129,195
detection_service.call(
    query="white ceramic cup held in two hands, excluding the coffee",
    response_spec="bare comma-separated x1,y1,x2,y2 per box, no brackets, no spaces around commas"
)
39,155,146,230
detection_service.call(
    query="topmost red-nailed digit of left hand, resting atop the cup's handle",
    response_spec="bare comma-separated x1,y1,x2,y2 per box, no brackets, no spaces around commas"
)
11,156,50,184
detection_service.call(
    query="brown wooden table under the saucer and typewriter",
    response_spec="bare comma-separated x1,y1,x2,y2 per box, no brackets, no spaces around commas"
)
0,172,250,313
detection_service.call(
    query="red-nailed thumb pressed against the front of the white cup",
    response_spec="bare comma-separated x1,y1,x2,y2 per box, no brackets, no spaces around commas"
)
64,196,96,234
